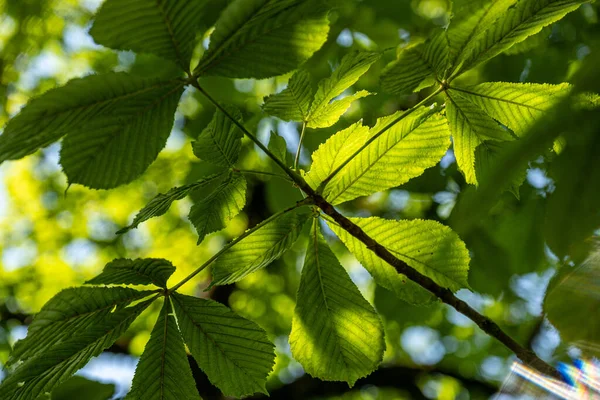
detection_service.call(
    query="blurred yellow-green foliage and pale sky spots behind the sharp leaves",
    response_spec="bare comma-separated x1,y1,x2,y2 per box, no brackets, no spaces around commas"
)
0,0,600,399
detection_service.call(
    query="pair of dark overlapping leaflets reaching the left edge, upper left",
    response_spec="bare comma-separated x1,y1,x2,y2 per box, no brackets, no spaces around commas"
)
0,73,183,188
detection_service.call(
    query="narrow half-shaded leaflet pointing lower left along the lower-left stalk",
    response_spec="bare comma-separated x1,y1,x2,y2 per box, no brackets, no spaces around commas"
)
211,211,307,285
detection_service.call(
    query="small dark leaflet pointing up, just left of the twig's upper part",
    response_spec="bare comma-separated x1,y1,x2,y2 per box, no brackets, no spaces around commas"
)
192,106,243,167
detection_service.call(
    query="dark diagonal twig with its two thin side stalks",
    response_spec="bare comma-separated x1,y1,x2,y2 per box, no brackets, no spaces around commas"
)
188,80,561,379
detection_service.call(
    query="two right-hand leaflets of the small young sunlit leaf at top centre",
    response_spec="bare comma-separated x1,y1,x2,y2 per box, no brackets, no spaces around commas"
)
306,51,381,128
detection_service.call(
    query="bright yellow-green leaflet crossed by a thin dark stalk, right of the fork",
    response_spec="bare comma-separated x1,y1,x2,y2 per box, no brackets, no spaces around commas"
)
307,107,450,204
